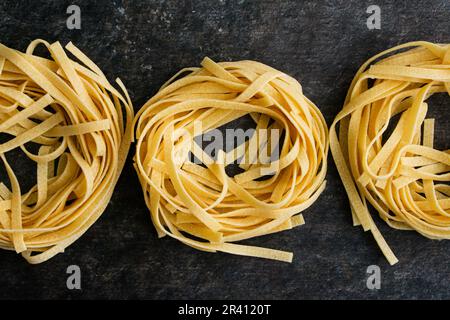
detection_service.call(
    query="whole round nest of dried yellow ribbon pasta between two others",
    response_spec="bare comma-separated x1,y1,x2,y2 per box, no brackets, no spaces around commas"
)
135,58,328,262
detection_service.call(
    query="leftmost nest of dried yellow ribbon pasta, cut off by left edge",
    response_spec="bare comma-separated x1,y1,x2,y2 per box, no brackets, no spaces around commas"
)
0,40,133,263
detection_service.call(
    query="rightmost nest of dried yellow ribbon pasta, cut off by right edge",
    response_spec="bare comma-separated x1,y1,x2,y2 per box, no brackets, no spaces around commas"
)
330,41,450,264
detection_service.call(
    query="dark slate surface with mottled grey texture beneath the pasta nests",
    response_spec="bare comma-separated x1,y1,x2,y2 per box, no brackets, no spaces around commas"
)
0,0,450,299
